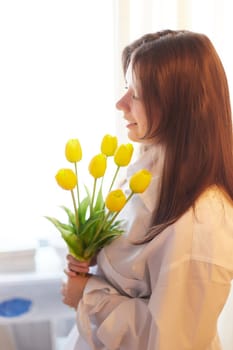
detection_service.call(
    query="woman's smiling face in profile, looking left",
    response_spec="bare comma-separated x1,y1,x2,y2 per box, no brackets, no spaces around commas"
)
116,64,147,142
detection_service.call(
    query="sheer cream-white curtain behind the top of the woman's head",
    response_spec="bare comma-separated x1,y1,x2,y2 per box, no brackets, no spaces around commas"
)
116,0,233,110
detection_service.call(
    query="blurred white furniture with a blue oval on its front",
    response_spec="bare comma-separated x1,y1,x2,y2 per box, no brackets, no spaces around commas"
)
0,247,75,350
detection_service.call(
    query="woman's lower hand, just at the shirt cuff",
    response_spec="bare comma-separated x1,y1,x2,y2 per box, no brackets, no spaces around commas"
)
61,274,90,309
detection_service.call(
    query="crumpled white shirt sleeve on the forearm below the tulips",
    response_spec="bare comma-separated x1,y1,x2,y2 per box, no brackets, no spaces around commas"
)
77,276,151,350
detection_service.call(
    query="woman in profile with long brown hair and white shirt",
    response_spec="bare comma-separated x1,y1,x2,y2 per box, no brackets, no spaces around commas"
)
62,30,233,350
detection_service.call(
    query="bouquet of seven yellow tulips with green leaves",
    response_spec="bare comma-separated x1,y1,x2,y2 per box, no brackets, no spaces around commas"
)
46,135,152,261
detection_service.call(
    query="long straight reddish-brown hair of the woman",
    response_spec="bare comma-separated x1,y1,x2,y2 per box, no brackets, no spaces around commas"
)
122,30,233,240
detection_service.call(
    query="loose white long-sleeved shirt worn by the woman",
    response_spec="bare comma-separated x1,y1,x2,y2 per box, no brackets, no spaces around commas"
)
69,146,233,350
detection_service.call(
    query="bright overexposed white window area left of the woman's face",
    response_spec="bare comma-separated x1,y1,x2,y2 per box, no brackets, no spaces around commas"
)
0,0,115,250
